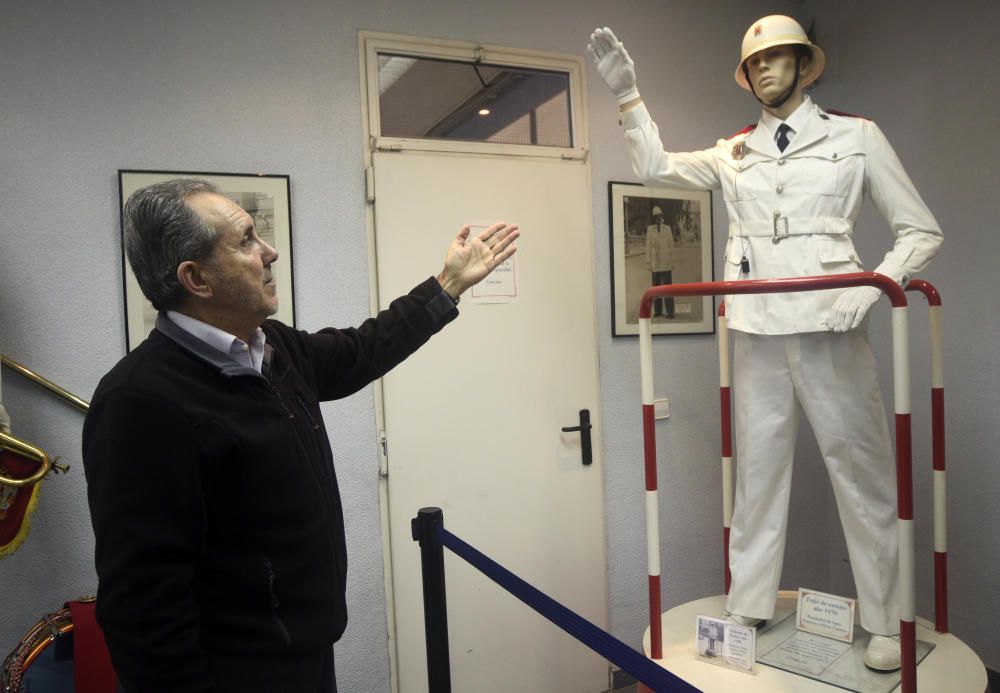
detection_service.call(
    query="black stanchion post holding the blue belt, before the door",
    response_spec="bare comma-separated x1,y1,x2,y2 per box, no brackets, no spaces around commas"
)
410,508,451,693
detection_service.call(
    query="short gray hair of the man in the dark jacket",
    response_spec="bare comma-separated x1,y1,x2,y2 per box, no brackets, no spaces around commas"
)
122,178,219,310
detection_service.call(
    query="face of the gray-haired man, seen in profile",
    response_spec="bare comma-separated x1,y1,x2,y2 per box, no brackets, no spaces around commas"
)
187,193,278,329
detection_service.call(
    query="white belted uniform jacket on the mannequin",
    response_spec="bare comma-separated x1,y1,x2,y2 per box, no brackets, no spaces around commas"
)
622,97,942,334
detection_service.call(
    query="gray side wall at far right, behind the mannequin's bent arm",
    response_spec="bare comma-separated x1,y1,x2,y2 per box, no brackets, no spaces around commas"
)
817,0,1000,669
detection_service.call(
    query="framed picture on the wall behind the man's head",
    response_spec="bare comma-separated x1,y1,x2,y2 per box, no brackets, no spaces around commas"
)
118,170,295,351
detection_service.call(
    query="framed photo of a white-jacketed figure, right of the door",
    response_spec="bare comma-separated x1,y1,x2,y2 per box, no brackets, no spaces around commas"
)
608,181,715,337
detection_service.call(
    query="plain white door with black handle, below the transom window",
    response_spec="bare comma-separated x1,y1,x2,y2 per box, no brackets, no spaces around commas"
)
374,151,607,693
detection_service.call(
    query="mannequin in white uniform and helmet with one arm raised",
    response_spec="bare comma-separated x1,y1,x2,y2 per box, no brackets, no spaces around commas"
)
589,15,941,670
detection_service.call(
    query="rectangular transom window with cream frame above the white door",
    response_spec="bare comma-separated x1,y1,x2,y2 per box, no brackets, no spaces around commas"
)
361,32,585,159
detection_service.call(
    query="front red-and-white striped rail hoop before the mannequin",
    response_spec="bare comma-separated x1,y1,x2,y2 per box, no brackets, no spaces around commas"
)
639,272,917,693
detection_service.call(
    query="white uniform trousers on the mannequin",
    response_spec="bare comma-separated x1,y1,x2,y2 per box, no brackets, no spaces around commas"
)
726,331,899,635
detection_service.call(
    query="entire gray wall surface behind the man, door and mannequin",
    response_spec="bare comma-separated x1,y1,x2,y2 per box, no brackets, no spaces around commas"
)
0,0,1000,691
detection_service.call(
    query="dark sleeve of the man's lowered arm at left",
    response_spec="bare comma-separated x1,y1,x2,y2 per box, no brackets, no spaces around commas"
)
83,390,215,693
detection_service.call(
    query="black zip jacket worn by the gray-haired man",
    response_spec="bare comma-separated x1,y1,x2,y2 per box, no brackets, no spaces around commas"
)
83,279,457,693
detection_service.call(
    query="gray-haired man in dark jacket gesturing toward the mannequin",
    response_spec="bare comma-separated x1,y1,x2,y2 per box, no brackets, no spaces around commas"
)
83,180,519,693
